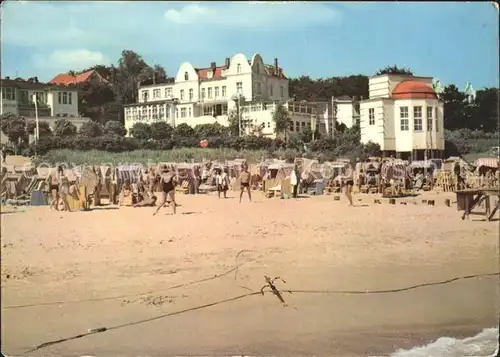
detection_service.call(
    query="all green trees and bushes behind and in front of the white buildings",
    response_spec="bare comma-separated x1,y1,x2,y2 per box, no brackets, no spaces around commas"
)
1,50,498,159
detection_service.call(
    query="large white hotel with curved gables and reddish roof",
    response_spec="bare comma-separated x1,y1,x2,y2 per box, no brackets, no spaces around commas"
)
125,53,342,137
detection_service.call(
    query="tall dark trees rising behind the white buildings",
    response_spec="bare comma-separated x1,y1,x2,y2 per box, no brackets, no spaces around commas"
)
69,50,499,132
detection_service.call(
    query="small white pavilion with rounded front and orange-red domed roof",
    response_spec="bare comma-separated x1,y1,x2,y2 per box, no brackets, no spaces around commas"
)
360,74,444,160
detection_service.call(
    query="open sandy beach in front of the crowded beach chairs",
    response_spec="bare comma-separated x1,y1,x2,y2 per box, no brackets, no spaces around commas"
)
1,192,500,356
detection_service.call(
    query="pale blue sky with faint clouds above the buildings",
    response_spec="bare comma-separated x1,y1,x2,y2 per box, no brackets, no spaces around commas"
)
1,0,499,89
